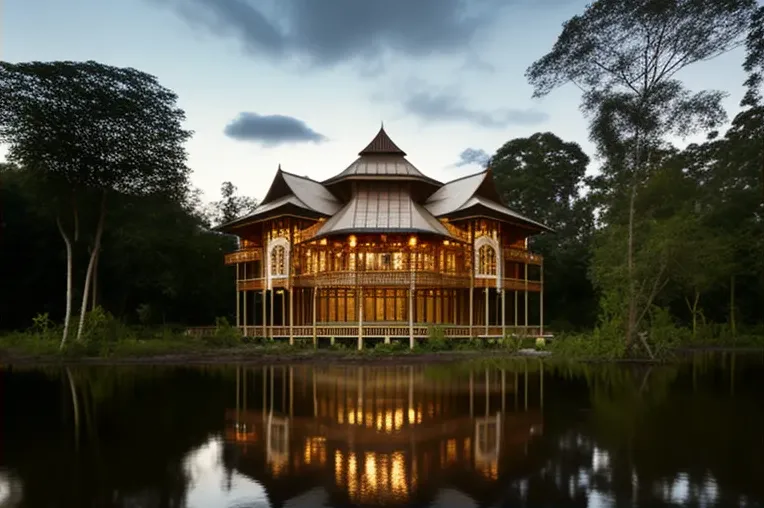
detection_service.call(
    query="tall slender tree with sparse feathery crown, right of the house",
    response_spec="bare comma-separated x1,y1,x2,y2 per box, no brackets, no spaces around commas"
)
526,0,756,356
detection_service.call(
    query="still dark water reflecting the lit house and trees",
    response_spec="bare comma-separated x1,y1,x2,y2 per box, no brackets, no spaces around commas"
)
0,354,764,508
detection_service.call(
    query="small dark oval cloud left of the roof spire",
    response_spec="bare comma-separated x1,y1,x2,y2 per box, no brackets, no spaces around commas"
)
224,112,326,146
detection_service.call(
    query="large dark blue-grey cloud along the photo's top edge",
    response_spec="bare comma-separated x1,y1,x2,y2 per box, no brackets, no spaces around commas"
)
150,0,510,66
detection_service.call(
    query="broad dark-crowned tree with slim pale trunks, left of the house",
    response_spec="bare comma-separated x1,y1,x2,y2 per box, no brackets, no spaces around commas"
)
0,61,191,347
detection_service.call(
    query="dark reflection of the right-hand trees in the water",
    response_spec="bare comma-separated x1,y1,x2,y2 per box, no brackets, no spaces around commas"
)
502,358,764,506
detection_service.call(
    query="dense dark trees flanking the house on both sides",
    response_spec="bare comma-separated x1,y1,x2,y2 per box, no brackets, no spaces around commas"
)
0,0,764,356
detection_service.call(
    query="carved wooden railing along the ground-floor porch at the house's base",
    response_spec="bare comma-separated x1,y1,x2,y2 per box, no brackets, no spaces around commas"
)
186,323,540,339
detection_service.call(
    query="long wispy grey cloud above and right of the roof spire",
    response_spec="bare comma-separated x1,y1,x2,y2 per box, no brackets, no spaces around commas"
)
403,92,548,128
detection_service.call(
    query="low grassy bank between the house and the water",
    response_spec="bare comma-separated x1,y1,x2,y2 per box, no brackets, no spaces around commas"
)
0,309,764,361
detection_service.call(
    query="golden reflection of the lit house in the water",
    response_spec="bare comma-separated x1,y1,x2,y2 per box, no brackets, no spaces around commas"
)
224,367,543,506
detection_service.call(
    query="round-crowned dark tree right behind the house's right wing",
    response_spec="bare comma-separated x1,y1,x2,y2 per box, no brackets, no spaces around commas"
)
489,132,595,327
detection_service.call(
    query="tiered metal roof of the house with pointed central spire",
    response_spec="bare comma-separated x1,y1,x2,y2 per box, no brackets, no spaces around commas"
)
219,127,551,237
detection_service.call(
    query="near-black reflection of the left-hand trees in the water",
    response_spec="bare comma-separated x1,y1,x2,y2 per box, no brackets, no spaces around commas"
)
3,367,237,507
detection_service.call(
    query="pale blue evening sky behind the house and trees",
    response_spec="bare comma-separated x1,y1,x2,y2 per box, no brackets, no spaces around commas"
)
0,0,745,201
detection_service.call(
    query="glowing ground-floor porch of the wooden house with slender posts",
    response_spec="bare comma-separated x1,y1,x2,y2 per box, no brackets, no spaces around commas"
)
189,287,544,347
